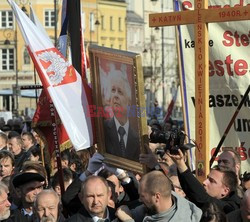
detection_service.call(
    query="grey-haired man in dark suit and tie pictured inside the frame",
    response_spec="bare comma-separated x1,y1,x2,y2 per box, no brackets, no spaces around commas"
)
100,60,140,162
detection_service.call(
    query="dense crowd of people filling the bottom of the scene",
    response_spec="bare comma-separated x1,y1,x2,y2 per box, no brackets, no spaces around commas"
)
0,115,250,222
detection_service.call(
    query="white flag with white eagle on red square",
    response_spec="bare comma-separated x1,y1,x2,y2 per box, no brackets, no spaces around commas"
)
8,0,93,150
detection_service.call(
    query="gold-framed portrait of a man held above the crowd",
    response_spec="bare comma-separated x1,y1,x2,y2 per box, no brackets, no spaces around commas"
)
89,46,148,173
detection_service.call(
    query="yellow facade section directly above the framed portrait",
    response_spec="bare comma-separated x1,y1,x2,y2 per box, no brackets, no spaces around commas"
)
82,0,127,50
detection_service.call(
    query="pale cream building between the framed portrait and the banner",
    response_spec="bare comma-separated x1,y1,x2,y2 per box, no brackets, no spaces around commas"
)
127,0,181,118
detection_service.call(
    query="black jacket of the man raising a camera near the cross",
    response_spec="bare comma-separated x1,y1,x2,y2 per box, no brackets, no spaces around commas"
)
178,169,240,214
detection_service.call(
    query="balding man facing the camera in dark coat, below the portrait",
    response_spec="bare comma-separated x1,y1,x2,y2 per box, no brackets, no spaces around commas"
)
67,176,116,222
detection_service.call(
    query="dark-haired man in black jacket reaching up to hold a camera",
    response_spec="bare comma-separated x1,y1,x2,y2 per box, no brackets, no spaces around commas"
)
167,149,240,213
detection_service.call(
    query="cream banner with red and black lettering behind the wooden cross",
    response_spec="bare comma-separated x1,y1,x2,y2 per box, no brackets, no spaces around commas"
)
178,0,250,172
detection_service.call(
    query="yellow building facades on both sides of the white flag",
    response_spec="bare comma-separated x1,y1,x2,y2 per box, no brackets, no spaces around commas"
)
0,0,127,115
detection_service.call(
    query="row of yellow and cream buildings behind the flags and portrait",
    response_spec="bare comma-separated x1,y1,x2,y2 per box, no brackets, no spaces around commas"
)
0,0,178,120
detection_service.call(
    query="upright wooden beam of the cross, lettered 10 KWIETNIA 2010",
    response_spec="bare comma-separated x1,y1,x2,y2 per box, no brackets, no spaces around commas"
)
194,0,209,181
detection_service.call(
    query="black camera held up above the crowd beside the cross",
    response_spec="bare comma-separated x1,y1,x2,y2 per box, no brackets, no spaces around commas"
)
150,127,194,156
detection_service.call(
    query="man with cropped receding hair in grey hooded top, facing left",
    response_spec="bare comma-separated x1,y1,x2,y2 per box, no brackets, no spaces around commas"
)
116,171,202,222
